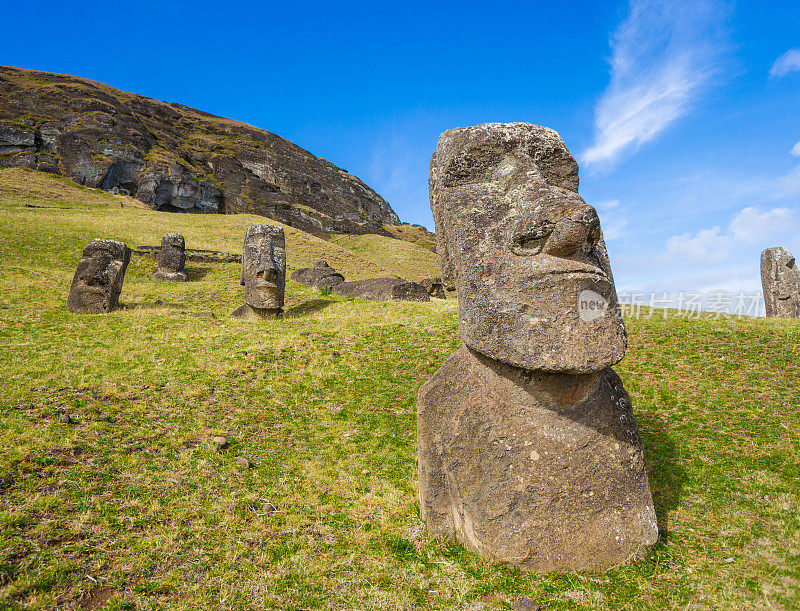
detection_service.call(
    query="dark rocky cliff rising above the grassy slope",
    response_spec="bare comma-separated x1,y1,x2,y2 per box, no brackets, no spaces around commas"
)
0,67,400,235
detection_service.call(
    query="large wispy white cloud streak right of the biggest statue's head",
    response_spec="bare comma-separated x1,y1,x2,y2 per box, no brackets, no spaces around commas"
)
582,0,729,165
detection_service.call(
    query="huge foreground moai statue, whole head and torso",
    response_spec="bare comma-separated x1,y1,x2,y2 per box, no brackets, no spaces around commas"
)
417,123,658,572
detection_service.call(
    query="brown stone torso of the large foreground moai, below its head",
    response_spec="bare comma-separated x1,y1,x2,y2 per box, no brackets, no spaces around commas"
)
417,347,658,572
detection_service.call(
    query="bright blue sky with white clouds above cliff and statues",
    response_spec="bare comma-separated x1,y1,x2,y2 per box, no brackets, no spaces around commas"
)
0,0,800,292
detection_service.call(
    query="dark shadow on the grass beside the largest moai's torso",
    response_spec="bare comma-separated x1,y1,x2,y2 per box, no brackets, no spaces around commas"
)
636,412,686,536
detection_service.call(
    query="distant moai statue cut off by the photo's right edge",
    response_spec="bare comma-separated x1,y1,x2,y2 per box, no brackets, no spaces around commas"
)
761,246,800,318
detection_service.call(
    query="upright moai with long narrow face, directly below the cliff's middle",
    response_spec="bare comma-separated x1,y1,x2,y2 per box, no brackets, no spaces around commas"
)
231,224,286,320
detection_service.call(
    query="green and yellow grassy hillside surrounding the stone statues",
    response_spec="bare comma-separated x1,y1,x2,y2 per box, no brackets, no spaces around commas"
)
0,172,800,610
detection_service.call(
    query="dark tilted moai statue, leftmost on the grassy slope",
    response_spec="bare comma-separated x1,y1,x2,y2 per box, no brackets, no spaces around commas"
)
67,240,131,314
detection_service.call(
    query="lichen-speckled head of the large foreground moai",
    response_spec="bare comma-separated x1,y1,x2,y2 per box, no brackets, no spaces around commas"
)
430,123,627,373
